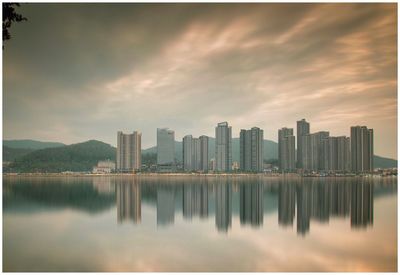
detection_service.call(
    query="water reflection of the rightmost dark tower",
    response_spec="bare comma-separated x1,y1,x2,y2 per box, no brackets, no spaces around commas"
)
351,182,374,227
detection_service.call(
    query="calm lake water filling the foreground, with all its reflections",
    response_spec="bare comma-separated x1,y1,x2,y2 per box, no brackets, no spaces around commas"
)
3,176,397,271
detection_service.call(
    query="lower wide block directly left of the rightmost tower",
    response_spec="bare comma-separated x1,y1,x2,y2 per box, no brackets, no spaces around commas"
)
322,136,350,171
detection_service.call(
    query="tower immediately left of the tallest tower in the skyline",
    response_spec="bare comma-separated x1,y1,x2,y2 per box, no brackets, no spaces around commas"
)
278,127,296,171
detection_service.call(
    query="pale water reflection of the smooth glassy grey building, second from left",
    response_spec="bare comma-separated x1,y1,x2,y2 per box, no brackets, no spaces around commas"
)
157,190,175,225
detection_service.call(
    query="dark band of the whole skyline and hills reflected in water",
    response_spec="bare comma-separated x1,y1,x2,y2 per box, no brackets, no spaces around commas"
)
3,177,384,235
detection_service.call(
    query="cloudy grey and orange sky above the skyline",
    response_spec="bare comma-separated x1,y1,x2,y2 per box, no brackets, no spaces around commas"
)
3,3,397,159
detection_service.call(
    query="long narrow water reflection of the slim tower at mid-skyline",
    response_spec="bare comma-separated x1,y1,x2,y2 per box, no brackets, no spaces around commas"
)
215,183,232,232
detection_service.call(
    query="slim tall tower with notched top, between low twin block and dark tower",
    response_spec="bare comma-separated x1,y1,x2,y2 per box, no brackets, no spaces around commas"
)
215,122,232,172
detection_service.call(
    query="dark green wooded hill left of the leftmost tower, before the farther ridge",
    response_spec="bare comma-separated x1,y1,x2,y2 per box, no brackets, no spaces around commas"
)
7,140,115,172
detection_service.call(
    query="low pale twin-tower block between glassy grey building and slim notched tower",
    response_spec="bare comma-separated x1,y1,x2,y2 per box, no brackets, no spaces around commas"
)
182,135,208,172
